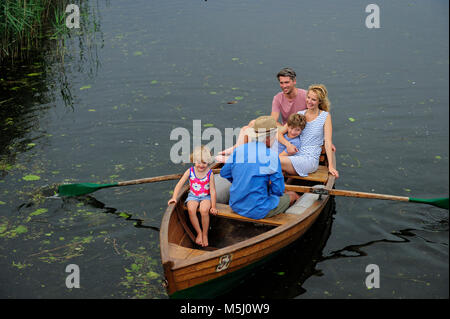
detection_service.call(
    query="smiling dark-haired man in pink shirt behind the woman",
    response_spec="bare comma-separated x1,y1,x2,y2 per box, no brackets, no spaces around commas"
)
270,68,306,125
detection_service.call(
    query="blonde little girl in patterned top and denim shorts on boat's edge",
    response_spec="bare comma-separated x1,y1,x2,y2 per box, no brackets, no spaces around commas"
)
168,145,217,247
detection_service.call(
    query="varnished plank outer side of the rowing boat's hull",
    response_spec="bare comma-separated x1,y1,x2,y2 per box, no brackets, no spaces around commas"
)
161,186,329,298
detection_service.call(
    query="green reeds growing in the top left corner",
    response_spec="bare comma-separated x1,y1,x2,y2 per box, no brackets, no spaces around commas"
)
0,0,73,64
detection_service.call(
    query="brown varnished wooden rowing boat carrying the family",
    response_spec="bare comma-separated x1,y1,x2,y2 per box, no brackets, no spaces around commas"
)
160,152,335,298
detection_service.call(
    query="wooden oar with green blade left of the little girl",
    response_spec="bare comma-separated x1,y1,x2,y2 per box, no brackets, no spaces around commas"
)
58,169,220,196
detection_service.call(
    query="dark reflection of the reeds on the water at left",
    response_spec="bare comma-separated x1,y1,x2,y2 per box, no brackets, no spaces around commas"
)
0,1,103,178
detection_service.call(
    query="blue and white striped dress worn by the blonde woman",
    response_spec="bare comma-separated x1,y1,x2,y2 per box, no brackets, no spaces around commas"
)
289,110,328,176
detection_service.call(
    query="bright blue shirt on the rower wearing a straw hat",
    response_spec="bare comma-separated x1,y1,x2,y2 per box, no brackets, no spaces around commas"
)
220,142,284,219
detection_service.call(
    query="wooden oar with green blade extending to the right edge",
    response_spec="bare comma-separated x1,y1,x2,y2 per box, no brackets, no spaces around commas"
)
286,185,448,209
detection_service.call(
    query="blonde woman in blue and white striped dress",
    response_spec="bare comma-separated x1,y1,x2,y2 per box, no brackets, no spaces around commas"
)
278,84,339,177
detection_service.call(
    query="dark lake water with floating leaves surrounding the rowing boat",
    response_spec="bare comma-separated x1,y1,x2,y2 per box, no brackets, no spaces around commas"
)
0,0,449,298
